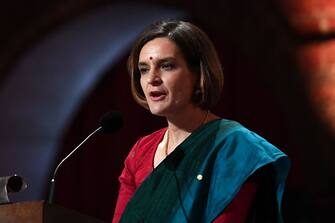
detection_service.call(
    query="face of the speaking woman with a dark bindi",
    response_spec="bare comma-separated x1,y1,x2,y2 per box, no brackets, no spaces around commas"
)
138,38,196,116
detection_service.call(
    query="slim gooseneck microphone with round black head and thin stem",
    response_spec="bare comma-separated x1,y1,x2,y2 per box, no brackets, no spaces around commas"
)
48,111,123,204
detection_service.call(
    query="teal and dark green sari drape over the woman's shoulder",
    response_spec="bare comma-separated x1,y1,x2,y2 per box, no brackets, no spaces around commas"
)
120,119,289,223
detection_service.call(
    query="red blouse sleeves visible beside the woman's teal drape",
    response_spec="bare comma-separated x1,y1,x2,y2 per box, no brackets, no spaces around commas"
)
113,128,256,223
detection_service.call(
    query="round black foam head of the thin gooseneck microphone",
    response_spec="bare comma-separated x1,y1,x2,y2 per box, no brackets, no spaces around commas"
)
100,111,123,133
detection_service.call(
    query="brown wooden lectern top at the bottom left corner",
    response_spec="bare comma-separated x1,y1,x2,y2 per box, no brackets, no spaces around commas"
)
0,201,104,223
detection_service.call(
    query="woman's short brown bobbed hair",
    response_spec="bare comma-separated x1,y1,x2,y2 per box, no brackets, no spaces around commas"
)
128,20,223,109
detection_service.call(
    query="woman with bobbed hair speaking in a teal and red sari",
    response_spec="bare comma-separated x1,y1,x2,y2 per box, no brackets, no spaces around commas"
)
113,21,288,223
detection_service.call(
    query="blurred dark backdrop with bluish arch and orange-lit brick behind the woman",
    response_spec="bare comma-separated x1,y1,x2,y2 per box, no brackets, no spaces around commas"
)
0,0,335,222
